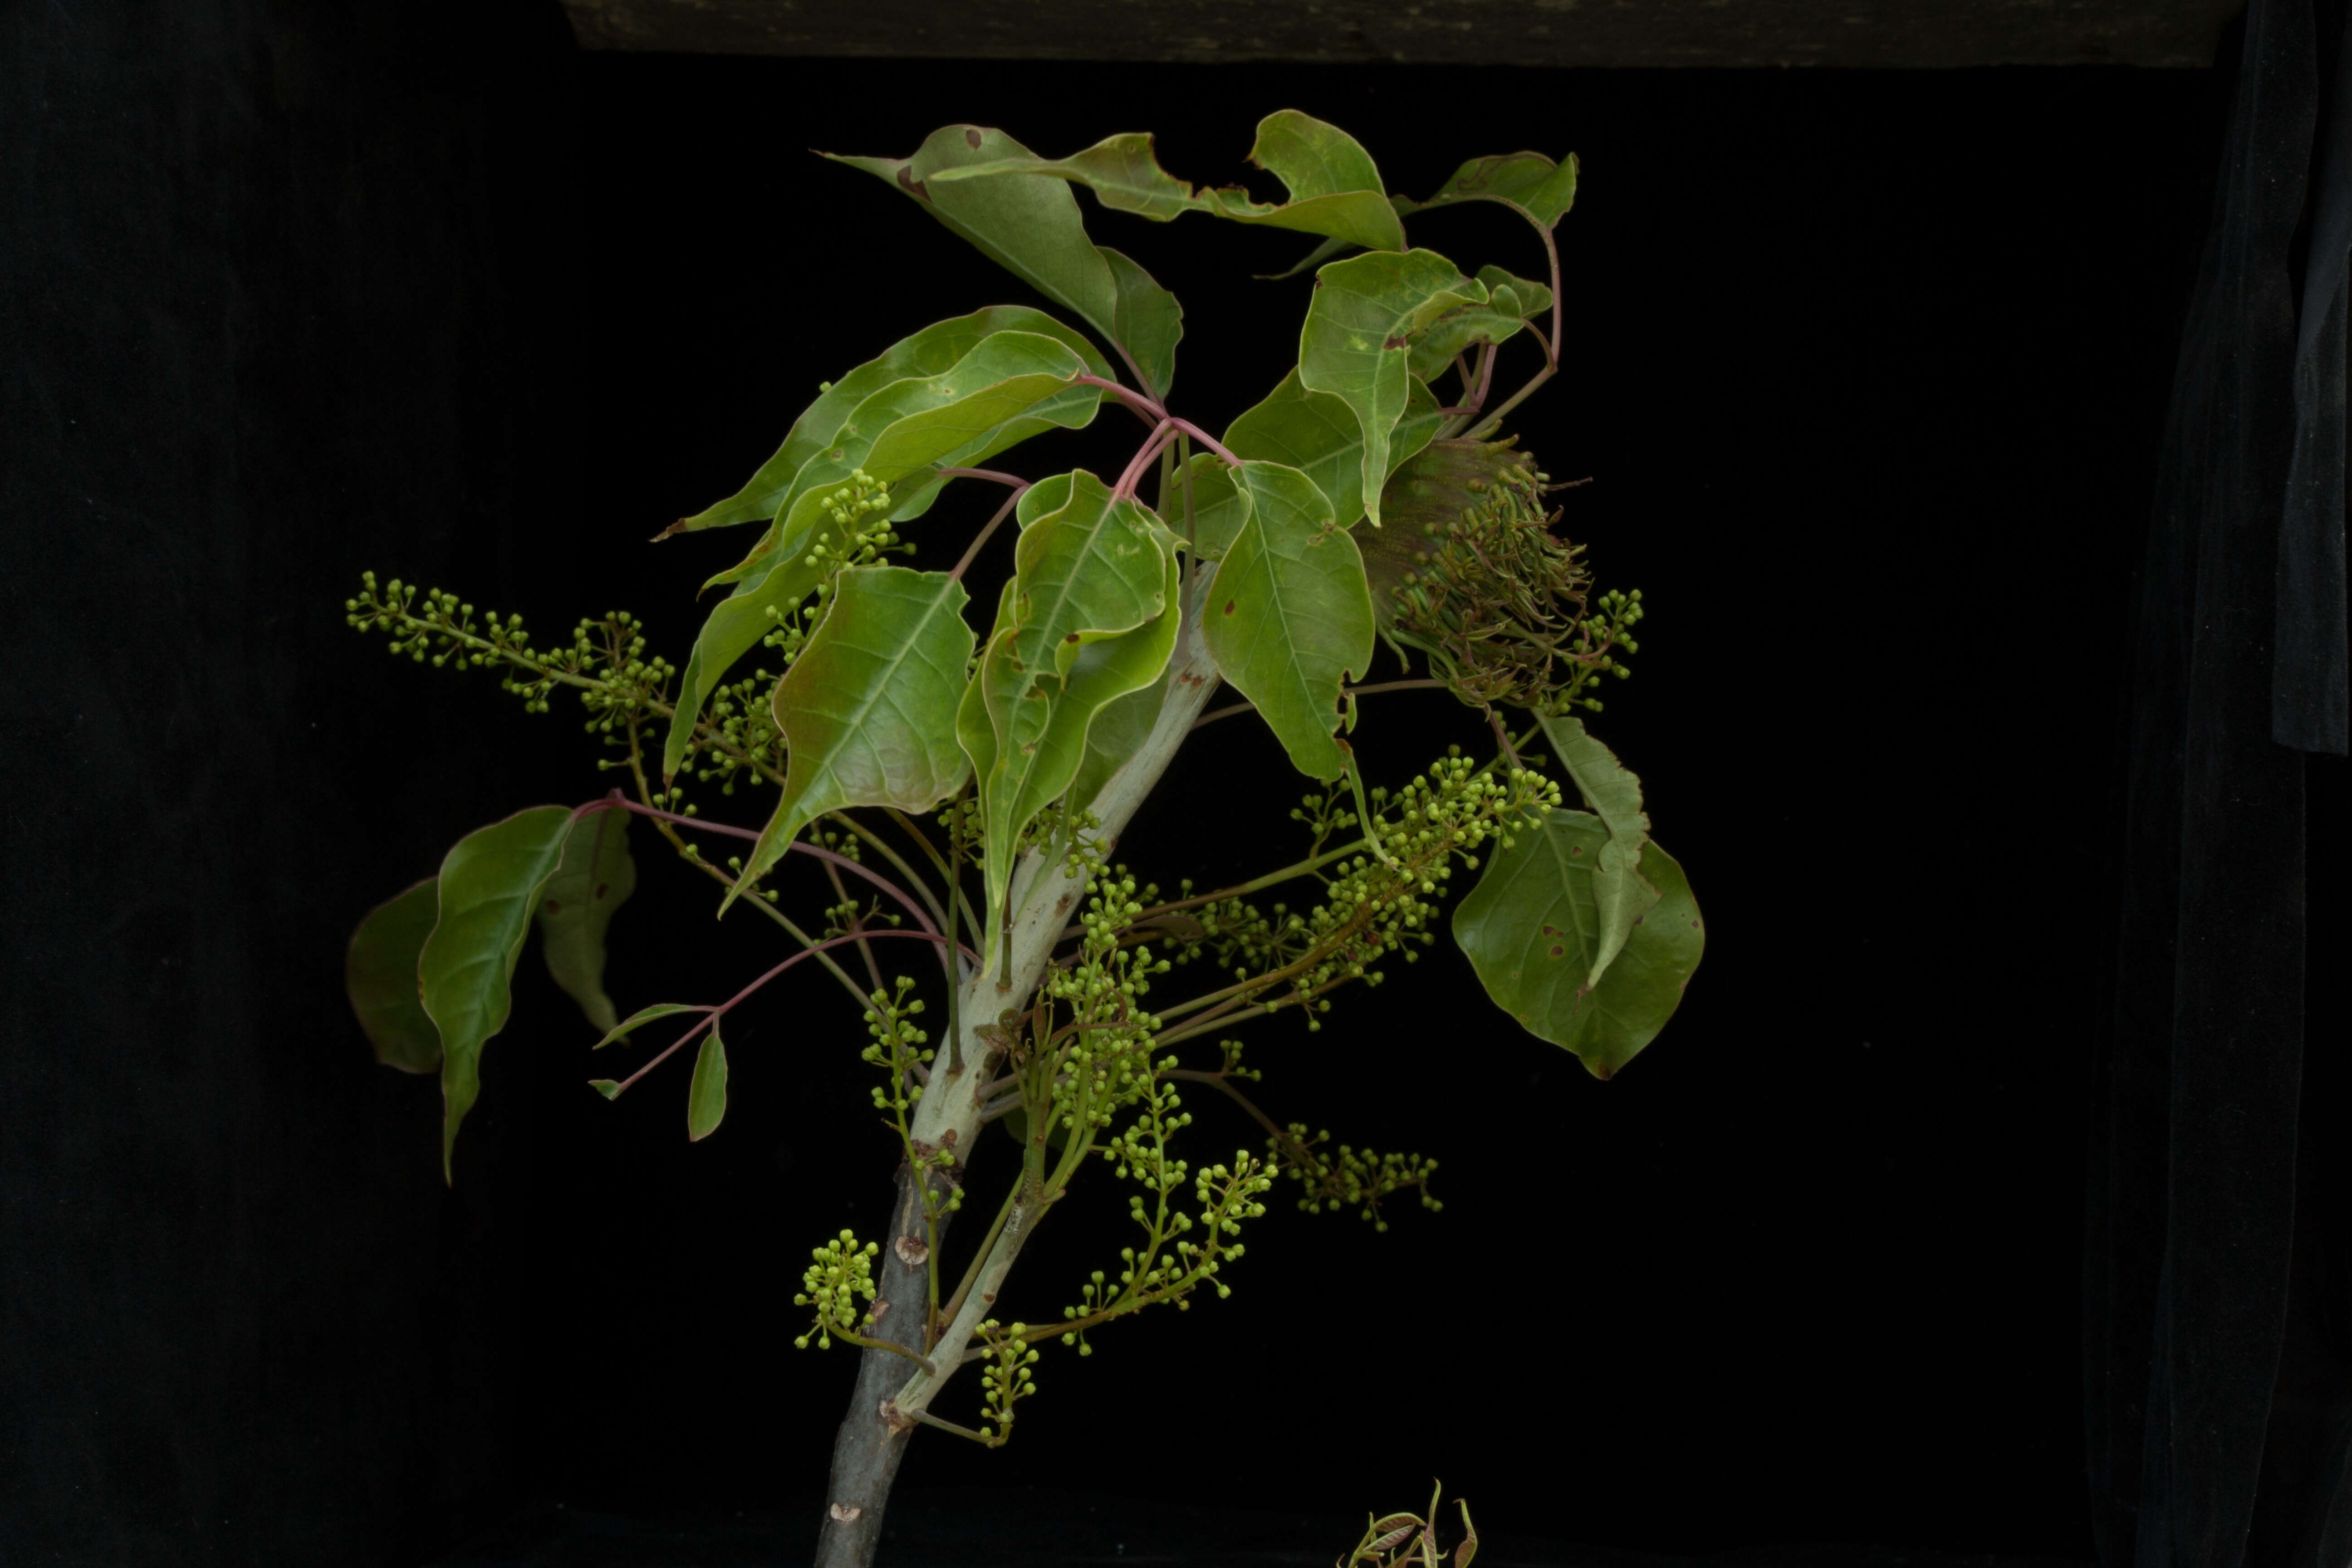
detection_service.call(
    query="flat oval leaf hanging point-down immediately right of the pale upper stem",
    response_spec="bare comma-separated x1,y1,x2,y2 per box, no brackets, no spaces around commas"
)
1202,463,1373,780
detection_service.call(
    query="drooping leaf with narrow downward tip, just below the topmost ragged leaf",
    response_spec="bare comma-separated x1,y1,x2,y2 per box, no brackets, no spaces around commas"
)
1298,251,1486,527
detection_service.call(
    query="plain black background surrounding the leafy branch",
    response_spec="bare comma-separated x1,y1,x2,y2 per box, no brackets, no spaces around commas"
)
0,12,2215,1563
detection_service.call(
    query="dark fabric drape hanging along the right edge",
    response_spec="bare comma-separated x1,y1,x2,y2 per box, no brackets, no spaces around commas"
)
2084,0,2352,1568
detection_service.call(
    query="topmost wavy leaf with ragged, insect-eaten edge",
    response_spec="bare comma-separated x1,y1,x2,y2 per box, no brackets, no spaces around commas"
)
931,108,1404,251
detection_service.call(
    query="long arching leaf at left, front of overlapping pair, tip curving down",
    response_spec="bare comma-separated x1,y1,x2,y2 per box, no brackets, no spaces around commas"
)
661,332,1101,778
